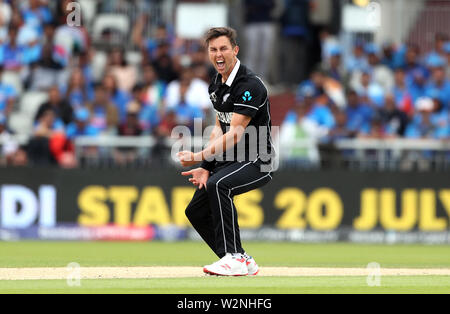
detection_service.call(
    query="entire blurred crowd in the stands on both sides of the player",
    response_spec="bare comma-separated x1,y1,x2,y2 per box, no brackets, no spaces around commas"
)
0,0,450,167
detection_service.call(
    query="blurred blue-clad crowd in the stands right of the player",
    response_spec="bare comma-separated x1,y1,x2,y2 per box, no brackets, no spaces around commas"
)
281,31,450,155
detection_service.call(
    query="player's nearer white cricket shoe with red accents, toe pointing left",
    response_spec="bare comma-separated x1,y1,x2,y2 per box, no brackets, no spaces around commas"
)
203,253,248,276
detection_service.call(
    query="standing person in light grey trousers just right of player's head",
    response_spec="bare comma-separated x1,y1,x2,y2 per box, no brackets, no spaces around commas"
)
244,0,275,80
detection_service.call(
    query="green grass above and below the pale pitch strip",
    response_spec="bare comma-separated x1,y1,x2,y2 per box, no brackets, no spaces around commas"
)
0,242,450,294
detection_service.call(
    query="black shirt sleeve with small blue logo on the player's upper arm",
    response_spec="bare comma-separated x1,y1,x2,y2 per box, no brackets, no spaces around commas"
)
233,80,267,118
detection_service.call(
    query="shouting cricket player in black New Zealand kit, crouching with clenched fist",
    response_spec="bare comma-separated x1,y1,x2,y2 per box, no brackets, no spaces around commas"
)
178,27,275,276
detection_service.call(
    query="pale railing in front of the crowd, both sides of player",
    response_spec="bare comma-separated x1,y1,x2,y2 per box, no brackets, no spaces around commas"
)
69,136,450,171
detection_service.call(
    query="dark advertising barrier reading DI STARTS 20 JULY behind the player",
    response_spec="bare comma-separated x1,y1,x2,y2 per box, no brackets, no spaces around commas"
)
0,168,450,232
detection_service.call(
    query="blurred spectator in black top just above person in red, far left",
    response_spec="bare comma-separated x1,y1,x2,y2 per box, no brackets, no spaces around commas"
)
34,86,73,125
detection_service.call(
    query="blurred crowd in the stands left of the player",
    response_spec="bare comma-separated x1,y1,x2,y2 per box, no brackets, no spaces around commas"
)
0,0,212,167
